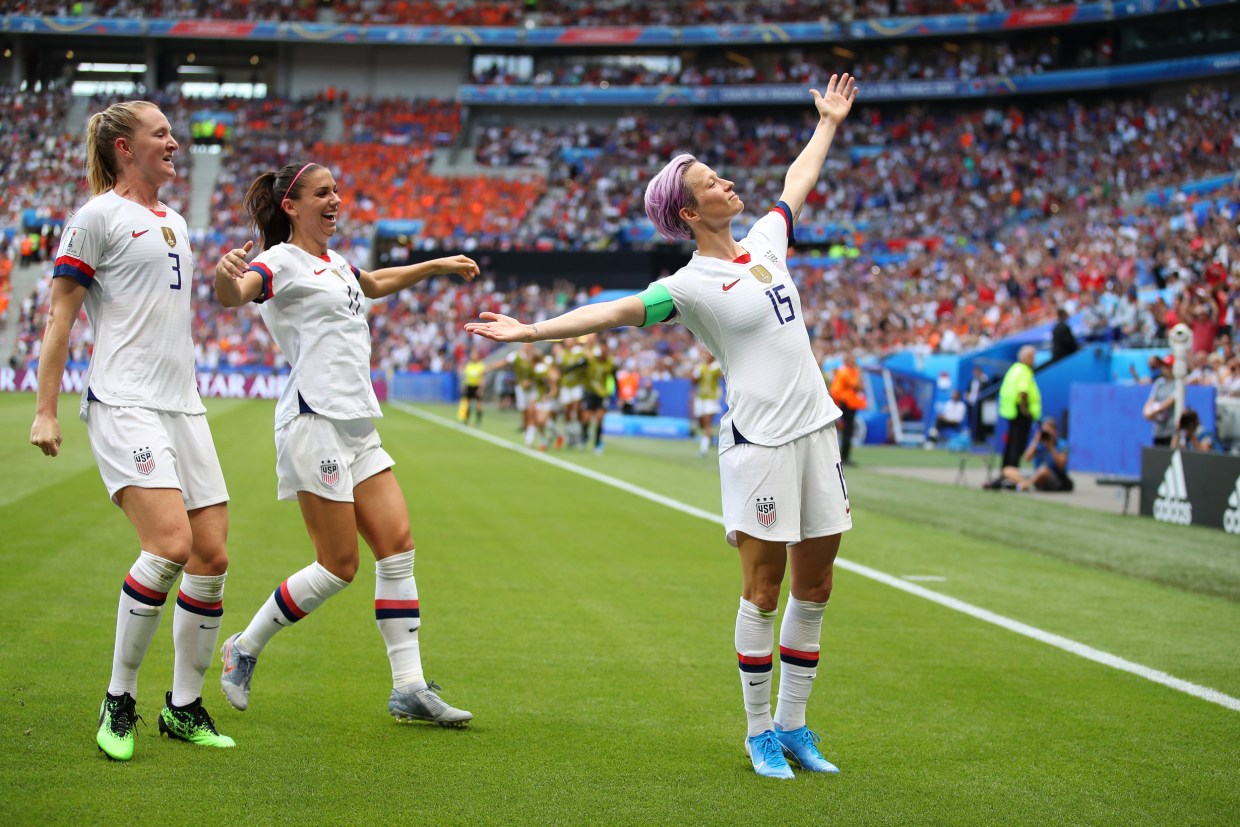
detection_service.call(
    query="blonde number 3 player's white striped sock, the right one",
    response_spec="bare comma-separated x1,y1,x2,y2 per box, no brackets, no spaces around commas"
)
172,573,228,707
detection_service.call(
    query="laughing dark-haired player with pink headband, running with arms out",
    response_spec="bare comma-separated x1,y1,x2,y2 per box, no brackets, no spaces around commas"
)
216,164,479,725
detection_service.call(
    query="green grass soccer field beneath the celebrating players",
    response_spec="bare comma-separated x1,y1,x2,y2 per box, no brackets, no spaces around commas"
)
0,394,1240,825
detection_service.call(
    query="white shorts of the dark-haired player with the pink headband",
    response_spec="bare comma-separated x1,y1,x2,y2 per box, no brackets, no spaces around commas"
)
275,414,396,502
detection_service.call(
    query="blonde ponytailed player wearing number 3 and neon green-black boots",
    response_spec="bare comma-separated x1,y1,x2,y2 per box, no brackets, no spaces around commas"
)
30,100,236,761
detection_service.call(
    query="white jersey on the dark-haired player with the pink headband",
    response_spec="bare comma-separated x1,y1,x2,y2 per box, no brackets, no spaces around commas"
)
249,243,383,429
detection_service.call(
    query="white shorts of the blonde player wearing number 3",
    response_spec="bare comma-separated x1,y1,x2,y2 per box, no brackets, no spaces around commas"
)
87,402,228,511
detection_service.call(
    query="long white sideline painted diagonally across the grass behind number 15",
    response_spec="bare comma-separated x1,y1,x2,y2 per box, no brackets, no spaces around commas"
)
391,402,1240,712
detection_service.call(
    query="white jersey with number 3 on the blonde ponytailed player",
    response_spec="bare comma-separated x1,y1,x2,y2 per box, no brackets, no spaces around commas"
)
52,191,206,419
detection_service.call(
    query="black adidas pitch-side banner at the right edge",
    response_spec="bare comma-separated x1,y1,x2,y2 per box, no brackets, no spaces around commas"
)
1141,448,1240,534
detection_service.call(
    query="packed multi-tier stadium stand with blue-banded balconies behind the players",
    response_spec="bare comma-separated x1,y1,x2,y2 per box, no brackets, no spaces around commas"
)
0,0,1240,458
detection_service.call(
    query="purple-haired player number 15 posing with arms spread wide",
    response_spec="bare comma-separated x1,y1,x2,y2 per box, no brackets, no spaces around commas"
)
465,74,857,779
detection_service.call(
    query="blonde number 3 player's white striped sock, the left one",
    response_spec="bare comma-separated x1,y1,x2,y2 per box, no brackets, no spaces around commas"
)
108,552,181,698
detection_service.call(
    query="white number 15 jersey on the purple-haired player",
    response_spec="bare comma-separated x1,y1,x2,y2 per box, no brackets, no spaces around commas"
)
658,203,839,454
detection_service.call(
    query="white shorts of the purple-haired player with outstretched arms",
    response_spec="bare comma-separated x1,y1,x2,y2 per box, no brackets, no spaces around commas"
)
719,423,852,546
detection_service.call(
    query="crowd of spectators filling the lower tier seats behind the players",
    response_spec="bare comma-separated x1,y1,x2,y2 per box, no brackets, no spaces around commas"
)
0,88,1240,394
